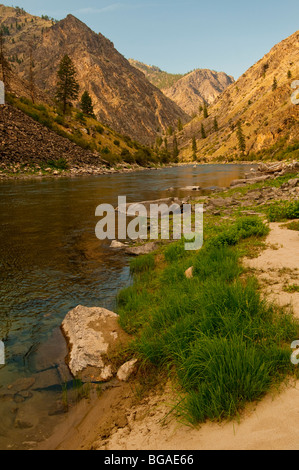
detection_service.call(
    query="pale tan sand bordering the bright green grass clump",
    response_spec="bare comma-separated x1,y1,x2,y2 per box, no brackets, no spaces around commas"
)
94,224,299,450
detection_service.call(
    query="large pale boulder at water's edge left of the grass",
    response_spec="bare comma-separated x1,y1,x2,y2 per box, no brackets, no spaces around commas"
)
62,305,127,382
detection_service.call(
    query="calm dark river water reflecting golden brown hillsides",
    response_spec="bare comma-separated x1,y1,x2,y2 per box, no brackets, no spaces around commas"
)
0,165,252,449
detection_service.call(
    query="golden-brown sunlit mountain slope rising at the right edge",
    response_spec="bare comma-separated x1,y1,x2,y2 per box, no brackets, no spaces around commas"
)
178,31,299,160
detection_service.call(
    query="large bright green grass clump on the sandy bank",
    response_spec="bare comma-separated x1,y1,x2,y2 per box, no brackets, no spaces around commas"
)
118,217,298,424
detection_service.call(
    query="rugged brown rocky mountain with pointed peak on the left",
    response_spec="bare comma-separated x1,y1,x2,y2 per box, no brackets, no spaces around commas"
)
0,5,189,144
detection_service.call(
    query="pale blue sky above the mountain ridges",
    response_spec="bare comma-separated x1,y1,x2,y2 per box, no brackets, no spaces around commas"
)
3,0,299,79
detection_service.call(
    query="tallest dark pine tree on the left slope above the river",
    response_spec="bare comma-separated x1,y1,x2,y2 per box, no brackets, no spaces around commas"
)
56,55,79,114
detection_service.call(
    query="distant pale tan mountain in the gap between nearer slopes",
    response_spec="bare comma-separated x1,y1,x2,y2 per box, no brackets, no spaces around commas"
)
163,69,234,115
